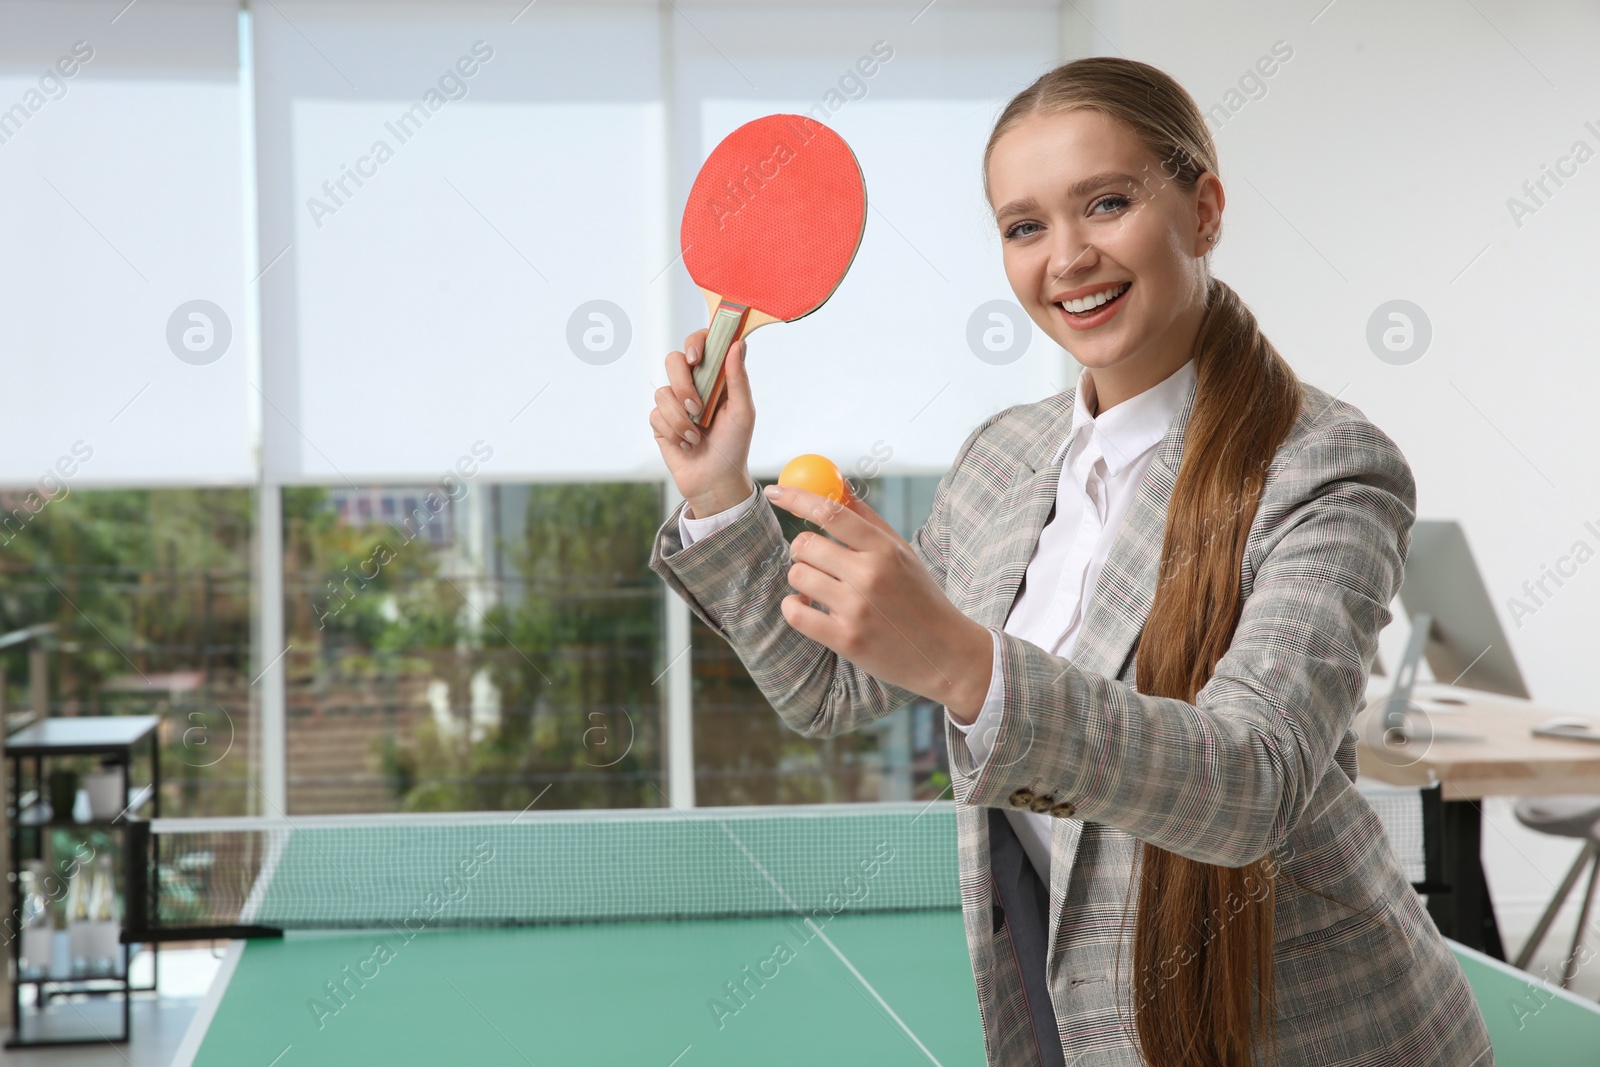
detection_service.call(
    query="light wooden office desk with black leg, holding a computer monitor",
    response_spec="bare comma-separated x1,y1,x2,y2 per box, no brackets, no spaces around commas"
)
1355,678,1600,960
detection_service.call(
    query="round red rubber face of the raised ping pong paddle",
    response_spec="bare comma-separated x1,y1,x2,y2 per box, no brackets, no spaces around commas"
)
680,115,867,322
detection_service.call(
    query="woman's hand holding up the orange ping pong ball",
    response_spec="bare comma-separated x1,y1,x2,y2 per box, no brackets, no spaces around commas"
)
763,485,994,721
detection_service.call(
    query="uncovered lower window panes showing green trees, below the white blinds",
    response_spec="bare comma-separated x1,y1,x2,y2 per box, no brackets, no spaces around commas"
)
0,477,947,814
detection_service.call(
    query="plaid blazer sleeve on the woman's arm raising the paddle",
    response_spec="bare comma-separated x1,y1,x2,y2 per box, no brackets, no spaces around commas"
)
650,408,1011,737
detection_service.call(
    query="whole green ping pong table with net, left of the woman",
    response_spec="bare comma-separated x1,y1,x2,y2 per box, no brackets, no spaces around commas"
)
138,803,984,1067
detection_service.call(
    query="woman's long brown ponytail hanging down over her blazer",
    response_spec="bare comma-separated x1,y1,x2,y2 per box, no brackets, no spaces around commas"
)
1133,278,1301,1067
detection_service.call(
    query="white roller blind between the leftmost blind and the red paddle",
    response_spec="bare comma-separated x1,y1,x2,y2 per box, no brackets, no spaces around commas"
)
256,3,675,485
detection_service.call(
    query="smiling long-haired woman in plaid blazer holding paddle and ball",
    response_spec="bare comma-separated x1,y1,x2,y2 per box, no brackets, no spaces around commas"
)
650,58,1493,1067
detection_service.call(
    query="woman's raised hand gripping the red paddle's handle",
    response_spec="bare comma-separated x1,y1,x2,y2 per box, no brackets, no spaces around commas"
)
650,330,755,518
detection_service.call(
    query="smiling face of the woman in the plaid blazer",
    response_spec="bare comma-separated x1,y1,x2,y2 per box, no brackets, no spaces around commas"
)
989,109,1222,386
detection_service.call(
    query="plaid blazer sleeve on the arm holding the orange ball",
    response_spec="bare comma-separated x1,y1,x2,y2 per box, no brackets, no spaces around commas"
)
950,421,1416,867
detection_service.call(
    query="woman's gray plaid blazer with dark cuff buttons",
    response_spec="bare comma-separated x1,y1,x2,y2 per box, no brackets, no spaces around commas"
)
650,371,1493,1067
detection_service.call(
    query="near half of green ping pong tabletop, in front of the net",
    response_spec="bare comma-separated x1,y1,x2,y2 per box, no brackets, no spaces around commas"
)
174,912,984,1067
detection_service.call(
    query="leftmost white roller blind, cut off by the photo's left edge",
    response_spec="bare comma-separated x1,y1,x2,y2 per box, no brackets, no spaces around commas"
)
0,0,254,491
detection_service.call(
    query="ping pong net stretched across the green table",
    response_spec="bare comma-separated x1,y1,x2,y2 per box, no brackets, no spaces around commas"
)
123,801,960,942
